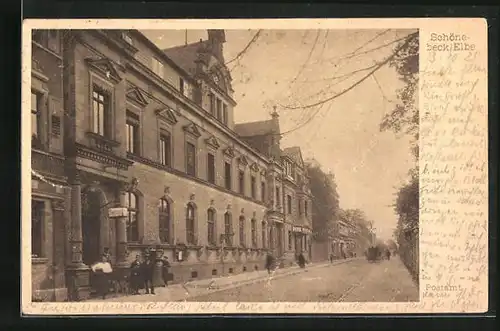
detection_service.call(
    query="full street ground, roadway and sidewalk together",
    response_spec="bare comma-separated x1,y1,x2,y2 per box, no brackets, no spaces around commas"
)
95,257,419,302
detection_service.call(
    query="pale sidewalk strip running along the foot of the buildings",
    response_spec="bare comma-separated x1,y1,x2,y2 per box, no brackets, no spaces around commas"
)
89,258,359,302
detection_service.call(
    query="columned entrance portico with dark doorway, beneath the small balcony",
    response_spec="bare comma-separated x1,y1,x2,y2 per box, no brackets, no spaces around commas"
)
66,169,137,301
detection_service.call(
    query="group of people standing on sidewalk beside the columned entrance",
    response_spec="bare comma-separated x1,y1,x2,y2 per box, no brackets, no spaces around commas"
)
91,250,172,299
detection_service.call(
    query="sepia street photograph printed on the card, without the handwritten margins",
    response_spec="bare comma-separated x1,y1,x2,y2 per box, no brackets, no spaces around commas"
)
31,29,419,302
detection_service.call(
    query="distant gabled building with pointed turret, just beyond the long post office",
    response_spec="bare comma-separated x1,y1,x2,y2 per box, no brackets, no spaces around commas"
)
235,111,312,265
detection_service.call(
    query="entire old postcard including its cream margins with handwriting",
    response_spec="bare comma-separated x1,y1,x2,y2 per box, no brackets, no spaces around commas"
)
21,18,488,315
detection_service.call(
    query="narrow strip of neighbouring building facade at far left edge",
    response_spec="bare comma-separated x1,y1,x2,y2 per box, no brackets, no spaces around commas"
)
30,30,68,301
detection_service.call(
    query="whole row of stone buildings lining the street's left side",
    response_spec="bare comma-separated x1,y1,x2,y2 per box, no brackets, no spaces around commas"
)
31,30,311,300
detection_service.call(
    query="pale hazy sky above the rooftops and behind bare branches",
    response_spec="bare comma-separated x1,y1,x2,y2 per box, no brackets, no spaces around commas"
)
142,30,415,239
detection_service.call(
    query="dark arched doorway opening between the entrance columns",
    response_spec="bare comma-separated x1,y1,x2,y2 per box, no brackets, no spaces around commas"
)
82,189,101,265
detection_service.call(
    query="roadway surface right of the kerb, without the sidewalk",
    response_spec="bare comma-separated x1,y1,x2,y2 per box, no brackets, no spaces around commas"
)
188,257,419,302
